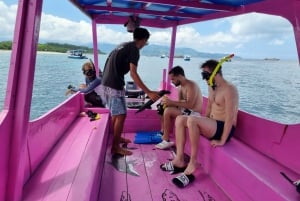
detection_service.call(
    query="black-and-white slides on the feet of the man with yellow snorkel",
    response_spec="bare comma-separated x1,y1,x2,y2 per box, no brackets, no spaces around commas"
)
160,161,195,188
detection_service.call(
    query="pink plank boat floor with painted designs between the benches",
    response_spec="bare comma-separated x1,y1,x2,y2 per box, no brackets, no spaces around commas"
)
99,133,230,201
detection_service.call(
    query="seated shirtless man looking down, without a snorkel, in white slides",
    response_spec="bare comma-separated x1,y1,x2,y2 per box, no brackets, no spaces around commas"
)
155,66,203,149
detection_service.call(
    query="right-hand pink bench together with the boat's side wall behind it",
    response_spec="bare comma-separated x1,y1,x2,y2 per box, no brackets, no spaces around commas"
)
192,112,300,201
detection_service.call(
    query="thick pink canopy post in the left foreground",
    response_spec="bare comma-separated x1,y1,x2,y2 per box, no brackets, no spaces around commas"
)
4,0,43,201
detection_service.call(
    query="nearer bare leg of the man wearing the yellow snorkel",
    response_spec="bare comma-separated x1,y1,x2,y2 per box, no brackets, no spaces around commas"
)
184,116,217,174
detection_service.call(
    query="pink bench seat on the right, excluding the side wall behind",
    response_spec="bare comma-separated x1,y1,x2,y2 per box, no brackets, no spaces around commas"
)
199,138,300,201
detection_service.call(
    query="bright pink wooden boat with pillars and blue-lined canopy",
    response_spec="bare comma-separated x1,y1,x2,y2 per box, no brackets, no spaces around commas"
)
0,0,300,201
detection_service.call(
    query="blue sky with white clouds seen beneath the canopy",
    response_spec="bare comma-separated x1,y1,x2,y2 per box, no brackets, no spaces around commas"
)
0,0,297,60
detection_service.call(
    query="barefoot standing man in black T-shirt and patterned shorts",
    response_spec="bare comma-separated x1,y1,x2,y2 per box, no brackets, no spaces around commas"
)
102,28,160,155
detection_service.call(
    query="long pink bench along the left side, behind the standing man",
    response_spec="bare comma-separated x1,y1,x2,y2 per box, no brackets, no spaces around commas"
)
22,114,109,201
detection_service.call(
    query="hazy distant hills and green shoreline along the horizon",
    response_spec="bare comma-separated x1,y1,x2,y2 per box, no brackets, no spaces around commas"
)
0,41,238,59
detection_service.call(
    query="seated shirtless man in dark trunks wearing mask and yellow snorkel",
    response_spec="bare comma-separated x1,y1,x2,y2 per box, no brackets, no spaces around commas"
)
161,60,239,187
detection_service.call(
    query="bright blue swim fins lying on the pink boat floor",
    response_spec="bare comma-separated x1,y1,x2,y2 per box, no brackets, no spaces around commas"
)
134,131,162,144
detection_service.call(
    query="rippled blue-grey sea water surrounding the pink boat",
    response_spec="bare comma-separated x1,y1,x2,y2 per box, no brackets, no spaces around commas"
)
0,51,300,124
